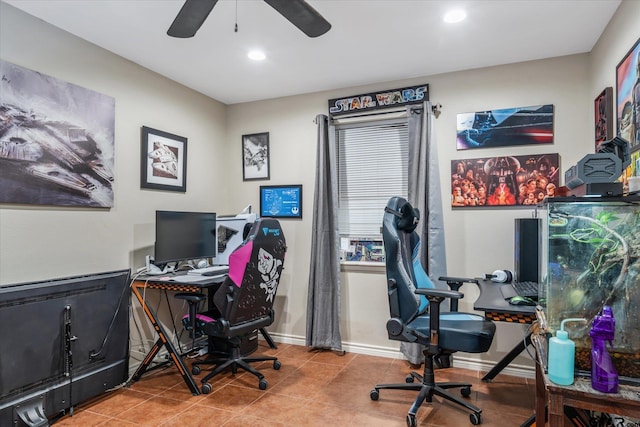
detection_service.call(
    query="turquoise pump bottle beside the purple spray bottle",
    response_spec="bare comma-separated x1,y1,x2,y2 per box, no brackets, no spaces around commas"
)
548,318,587,385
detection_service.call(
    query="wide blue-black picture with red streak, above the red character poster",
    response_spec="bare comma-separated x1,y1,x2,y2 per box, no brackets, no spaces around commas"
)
456,104,554,150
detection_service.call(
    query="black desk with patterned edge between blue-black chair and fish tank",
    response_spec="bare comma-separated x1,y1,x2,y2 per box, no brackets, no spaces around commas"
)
473,279,536,381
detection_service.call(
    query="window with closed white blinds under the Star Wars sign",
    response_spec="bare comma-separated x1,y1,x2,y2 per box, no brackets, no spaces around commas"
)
336,118,408,262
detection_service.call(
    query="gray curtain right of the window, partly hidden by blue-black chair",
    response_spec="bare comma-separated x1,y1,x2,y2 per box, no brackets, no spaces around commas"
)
400,101,448,365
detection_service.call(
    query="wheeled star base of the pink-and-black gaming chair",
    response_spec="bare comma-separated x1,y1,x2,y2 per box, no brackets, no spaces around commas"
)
191,347,282,394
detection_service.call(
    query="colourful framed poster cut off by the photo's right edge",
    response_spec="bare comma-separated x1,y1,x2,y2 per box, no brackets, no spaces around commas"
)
616,39,640,152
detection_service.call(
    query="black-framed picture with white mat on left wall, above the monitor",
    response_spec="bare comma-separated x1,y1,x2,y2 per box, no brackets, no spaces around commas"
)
140,126,187,193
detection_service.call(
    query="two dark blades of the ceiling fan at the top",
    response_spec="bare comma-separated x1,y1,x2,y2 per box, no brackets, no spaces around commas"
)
167,0,331,38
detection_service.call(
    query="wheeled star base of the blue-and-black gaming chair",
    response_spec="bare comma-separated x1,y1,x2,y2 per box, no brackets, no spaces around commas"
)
369,368,482,427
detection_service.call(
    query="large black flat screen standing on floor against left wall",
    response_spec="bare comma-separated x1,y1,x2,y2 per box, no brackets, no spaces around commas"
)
0,270,131,427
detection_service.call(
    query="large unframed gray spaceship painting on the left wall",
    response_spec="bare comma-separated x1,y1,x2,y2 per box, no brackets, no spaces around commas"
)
0,60,115,207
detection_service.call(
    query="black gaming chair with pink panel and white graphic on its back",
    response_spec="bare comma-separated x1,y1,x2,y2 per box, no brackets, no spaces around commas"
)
192,218,287,394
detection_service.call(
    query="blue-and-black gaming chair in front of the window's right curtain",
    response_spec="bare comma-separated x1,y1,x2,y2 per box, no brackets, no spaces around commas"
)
370,197,496,427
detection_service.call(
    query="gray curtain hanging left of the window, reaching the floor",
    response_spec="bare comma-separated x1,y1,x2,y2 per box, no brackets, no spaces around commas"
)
306,114,342,351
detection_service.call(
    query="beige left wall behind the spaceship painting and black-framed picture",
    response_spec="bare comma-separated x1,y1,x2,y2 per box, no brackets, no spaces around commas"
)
0,3,230,284
